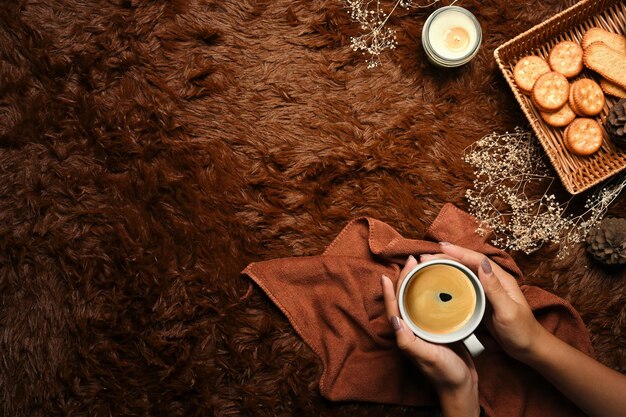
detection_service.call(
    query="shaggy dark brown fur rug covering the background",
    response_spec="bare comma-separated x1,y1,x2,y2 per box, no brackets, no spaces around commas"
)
0,0,626,417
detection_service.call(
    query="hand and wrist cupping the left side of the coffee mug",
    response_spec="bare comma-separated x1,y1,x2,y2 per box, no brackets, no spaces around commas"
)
382,256,480,417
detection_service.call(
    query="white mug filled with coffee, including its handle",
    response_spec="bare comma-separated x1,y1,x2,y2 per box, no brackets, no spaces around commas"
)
398,260,485,355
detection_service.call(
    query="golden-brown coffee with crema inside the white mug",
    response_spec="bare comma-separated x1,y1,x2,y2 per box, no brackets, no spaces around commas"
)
404,265,476,334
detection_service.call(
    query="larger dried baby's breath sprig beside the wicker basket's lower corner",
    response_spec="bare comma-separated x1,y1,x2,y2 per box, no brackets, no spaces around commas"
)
464,128,626,258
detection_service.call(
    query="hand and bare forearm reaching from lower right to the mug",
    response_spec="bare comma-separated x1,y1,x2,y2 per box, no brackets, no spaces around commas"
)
423,244,626,417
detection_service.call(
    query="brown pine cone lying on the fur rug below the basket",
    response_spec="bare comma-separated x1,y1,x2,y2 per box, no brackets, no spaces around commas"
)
587,217,626,265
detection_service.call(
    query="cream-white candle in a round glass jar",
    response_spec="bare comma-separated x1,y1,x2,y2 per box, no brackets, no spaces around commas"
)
422,6,482,67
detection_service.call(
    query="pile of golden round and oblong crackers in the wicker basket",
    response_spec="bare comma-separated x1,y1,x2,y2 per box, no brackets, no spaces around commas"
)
513,28,626,156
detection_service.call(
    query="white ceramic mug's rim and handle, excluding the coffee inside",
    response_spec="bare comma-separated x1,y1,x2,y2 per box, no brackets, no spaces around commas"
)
398,259,486,356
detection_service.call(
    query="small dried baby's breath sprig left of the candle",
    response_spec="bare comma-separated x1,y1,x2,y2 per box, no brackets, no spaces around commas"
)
344,0,448,68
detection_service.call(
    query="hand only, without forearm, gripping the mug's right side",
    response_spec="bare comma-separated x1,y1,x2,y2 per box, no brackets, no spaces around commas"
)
422,244,547,361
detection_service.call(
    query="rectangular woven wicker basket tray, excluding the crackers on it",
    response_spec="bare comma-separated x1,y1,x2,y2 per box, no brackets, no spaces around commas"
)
494,0,626,194
